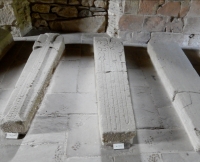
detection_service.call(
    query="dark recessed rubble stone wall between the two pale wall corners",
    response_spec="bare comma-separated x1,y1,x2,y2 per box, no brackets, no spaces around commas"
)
29,0,107,33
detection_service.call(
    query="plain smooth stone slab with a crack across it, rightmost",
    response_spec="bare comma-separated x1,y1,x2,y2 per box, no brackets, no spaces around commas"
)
148,41,200,151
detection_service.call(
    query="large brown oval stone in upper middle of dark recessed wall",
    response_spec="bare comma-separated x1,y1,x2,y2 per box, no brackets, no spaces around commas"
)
51,6,78,18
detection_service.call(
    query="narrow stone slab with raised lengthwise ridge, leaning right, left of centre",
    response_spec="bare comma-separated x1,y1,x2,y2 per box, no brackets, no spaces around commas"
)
1,34,65,133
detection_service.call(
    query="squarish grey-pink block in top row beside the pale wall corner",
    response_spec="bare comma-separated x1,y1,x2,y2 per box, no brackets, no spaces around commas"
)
122,0,139,14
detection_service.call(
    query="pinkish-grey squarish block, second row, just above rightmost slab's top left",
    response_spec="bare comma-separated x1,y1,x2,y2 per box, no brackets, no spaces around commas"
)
143,16,167,32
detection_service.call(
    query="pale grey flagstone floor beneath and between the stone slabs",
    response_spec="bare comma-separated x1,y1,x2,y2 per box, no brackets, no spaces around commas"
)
0,34,200,162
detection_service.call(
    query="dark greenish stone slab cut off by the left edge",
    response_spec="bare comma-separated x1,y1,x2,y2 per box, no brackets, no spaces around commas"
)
0,28,13,60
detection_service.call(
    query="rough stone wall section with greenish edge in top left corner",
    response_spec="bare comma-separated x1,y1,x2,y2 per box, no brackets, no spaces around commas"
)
0,0,32,36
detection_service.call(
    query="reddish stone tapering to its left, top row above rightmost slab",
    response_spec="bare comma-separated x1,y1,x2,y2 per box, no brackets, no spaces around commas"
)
157,1,181,17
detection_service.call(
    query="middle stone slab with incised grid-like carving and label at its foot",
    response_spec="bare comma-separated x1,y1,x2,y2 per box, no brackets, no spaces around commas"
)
94,38,136,145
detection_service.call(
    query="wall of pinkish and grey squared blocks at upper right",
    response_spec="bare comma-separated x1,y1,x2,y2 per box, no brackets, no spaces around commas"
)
107,0,200,46
